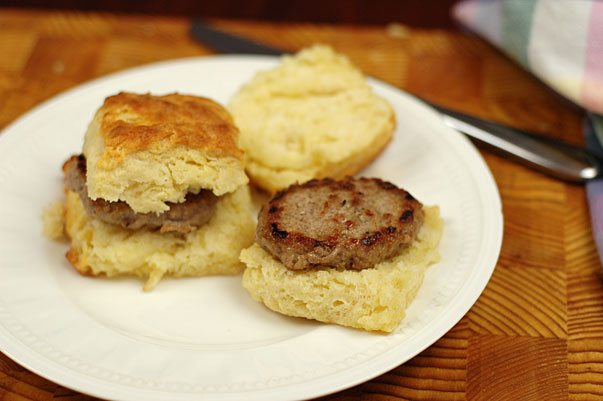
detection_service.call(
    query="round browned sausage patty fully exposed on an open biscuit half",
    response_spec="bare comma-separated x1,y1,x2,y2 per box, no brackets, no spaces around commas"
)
256,177,424,270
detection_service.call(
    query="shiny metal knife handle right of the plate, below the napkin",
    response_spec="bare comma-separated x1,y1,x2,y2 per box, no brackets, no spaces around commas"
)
432,105,601,183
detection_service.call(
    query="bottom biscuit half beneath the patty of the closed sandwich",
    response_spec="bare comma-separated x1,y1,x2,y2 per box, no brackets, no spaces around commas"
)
65,186,255,291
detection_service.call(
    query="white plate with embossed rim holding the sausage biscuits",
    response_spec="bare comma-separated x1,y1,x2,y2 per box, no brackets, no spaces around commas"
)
0,56,502,401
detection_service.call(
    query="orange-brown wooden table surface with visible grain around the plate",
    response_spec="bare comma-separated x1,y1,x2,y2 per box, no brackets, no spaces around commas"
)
0,9,603,401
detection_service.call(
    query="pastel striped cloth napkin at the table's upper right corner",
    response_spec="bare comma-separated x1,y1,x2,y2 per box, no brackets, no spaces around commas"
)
452,0,603,265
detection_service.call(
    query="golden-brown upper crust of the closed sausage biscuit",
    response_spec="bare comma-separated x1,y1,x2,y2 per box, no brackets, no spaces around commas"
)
98,92,243,169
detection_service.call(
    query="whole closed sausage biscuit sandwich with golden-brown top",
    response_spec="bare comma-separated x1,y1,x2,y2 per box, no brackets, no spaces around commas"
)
63,93,254,290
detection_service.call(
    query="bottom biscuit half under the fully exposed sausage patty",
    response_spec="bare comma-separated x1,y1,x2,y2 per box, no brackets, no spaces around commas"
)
240,206,444,332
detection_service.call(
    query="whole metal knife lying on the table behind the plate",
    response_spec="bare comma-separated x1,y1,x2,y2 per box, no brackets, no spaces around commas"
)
190,19,601,183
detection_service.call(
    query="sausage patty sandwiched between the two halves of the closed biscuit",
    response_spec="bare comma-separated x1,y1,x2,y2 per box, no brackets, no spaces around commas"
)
63,155,218,233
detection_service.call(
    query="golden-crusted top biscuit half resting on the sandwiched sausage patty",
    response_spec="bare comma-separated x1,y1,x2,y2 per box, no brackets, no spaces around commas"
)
84,93,248,213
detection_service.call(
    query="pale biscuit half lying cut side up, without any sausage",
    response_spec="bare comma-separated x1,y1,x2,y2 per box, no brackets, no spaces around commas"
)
229,45,395,192
